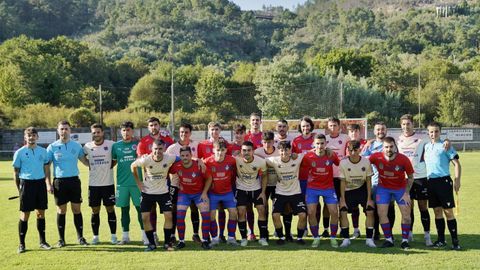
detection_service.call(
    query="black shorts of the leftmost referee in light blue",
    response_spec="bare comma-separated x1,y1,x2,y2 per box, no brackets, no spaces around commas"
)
20,179,48,212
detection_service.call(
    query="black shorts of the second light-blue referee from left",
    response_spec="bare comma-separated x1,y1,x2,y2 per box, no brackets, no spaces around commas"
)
53,176,83,205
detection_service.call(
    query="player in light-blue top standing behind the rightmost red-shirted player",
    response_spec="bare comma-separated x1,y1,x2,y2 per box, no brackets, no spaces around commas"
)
362,122,395,240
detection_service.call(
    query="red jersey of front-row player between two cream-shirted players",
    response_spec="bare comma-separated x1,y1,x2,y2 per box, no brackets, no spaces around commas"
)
301,152,340,189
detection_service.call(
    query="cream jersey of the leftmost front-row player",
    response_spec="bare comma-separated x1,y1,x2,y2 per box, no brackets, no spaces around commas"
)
133,154,176,194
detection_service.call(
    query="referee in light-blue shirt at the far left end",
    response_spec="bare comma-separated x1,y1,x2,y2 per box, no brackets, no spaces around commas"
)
12,127,53,253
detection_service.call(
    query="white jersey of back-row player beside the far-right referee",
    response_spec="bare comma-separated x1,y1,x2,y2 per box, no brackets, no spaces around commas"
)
397,133,429,179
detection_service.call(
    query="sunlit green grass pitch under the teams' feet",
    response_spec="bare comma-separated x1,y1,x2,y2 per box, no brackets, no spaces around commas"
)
0,152,480,270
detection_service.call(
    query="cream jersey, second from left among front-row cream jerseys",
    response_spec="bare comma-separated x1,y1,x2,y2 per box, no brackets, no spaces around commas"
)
235,155,267,191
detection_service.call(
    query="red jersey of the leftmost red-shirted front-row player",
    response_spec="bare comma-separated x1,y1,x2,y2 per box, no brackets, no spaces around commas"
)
170,160,208,194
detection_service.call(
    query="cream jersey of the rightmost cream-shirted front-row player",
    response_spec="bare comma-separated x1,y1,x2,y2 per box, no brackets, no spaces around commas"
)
339,157,373,191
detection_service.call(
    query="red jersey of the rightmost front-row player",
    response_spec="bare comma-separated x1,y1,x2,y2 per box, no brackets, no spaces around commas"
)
369,152,414,190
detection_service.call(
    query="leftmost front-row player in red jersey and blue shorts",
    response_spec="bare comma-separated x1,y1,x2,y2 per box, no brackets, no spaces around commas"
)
170,146,212,249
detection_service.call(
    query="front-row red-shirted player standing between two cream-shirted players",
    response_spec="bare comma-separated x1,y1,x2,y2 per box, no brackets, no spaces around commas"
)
302,134,340,248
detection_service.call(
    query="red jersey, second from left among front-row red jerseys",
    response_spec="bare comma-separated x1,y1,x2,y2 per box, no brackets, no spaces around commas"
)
205,155,237,194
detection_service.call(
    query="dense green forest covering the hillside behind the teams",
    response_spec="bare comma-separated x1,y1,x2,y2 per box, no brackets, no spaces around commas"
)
0,0,480,127
